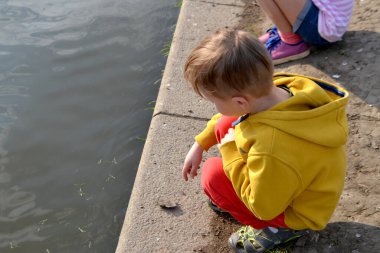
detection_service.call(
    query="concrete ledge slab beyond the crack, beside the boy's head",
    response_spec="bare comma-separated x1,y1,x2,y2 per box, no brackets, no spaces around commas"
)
154,0,243,118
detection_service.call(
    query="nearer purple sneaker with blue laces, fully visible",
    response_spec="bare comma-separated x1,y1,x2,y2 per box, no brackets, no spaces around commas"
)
265,35,310,65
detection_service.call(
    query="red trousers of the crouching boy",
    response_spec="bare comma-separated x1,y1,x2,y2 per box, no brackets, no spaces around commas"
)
201,116,288,229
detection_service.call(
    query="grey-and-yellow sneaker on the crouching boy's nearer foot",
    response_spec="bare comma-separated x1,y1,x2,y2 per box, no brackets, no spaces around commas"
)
228,226,308,253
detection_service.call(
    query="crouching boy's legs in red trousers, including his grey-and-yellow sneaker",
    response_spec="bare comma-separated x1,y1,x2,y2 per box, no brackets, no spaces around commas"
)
209,116,303,252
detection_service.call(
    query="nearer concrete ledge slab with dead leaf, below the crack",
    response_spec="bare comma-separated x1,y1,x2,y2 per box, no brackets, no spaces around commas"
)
116,115,217,252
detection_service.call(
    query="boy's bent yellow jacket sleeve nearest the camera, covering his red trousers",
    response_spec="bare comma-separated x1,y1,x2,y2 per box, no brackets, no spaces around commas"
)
220,142,301,220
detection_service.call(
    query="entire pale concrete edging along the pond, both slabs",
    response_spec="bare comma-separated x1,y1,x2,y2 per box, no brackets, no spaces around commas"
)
116,0,244,253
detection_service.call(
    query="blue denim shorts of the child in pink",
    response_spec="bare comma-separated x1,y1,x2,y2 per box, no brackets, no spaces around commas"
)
293,0,332,47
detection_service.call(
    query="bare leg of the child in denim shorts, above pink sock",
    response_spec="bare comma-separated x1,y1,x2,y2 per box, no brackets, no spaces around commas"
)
256,0,306,33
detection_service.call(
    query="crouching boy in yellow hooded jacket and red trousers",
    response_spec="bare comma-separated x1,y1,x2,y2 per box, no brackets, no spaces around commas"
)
182,30,348,252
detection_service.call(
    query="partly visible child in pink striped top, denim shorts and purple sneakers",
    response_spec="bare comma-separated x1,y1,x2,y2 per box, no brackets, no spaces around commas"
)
256,0,354,64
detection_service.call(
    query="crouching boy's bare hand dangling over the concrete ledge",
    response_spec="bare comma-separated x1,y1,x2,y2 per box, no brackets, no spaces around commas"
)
182,142,203,181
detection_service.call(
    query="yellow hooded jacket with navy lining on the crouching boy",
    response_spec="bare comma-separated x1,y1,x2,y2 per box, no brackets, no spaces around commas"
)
195,73,349,230
